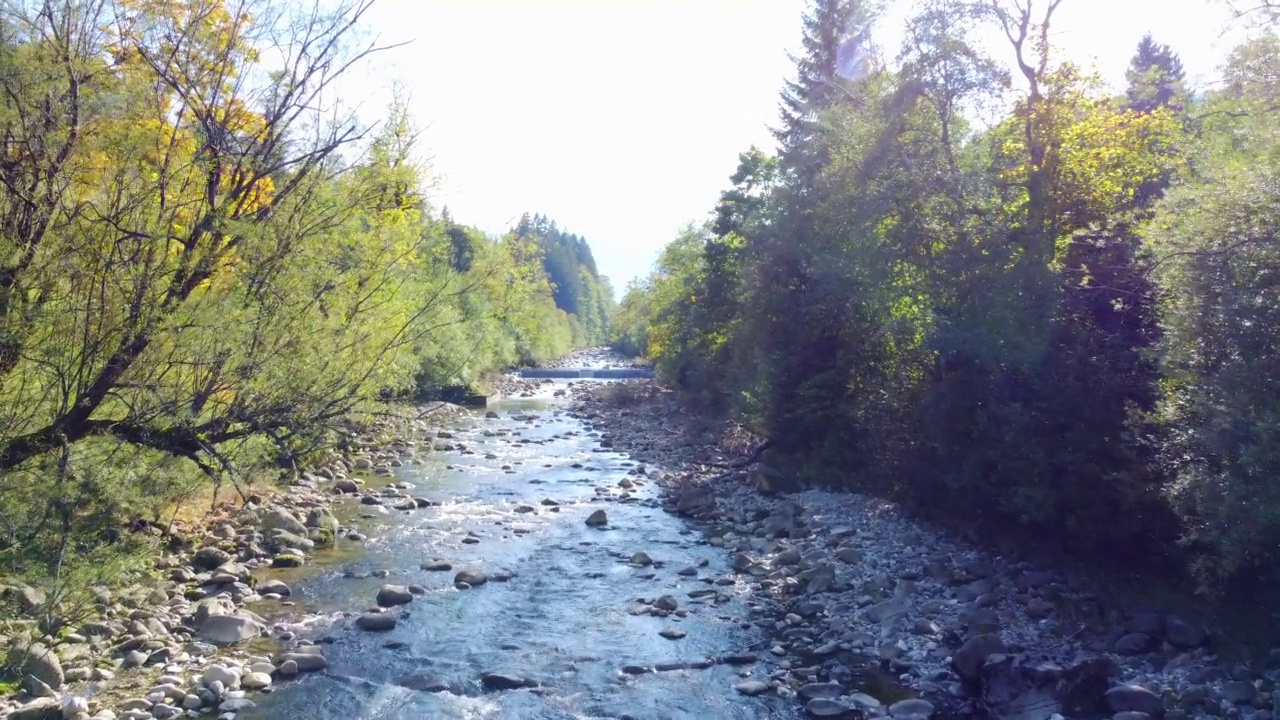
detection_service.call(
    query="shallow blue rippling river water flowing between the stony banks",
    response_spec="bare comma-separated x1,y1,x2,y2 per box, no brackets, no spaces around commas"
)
231,383,796,720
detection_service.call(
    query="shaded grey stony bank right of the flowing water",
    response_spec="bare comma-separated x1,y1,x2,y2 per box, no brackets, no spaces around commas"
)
573,383,1280,720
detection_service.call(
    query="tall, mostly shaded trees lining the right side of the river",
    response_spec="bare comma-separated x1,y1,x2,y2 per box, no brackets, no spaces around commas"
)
614,0,1280,589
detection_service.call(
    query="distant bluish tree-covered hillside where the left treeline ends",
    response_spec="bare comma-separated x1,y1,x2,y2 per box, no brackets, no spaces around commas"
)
512,213,617,347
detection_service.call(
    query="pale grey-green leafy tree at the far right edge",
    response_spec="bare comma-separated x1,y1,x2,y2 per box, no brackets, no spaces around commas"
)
1148,37,1280,583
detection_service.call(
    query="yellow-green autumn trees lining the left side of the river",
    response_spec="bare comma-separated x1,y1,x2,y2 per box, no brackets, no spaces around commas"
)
0,0,609,592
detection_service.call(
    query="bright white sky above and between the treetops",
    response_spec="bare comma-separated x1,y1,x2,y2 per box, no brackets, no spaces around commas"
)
347,0,1254,293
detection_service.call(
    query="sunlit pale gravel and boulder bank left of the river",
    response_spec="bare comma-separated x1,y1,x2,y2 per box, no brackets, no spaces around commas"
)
0,404,465,720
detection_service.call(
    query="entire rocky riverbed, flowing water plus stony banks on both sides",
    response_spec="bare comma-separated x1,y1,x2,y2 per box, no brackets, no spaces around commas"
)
0,360,1280,720
